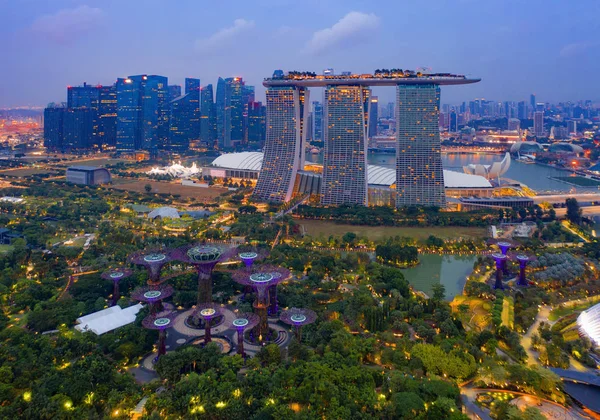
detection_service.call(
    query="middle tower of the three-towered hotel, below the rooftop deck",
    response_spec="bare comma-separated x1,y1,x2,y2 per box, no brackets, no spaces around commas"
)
321,85,371,206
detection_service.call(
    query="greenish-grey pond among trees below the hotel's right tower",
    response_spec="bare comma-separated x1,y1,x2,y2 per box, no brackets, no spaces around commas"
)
402,254,477,300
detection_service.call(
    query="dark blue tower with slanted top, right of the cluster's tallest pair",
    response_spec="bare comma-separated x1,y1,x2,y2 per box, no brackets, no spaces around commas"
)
168,91,197,153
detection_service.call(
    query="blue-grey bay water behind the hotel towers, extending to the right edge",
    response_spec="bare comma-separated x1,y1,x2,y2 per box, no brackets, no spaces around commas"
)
306,152,597,192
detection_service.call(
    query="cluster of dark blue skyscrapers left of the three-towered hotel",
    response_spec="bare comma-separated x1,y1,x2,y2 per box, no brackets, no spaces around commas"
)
44,75,266,156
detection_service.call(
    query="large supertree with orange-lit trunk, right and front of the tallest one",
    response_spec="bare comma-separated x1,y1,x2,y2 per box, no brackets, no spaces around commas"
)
233,265,290,341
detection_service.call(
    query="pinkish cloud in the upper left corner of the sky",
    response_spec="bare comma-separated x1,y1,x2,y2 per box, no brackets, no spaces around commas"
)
31,5,104,44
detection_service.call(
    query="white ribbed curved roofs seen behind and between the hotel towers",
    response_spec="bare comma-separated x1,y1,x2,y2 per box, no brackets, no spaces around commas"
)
211,152,492,189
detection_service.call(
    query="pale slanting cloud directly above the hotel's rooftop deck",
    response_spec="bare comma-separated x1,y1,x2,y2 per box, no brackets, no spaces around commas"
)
305,12,380,55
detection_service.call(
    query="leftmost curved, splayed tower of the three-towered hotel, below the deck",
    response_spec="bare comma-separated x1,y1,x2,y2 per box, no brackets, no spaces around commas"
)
254,86,309,202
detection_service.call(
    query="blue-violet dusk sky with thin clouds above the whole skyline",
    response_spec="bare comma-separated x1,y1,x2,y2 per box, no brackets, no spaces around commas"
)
0,0,600,107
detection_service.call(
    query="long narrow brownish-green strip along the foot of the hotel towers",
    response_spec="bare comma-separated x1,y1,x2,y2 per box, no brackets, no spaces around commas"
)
298,220,487,241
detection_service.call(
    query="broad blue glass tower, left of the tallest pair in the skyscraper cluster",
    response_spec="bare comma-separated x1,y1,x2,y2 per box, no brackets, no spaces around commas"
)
116,78,142,152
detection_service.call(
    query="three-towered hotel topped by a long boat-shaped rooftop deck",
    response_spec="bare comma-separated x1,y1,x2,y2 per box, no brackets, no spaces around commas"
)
254,70,480,207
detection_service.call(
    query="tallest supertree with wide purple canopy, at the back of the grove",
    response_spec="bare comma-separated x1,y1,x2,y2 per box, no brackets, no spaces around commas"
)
173,244,235,305
